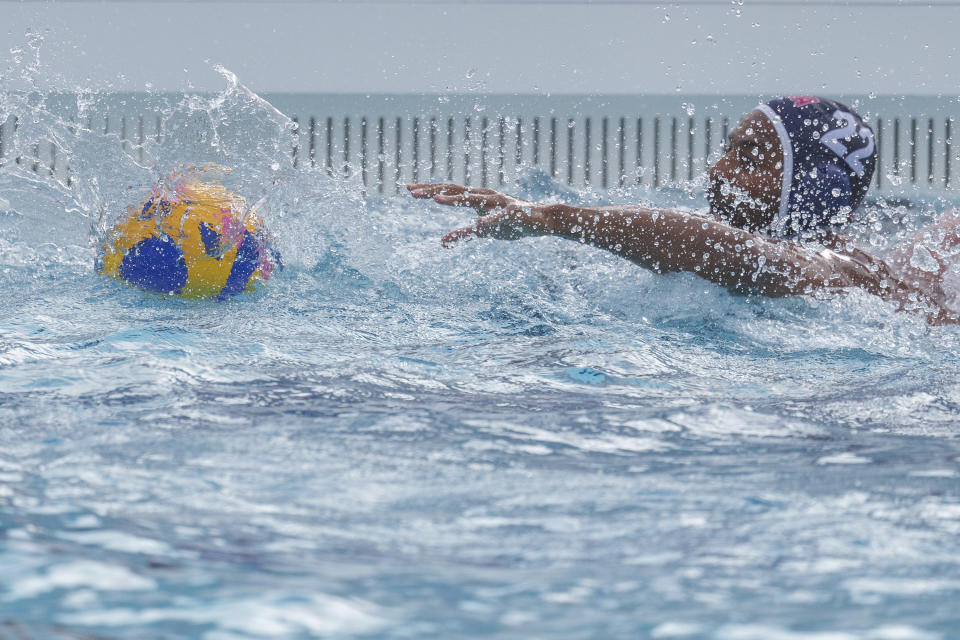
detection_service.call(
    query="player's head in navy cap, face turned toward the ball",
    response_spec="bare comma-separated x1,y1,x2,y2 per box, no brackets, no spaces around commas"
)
708,96,876,237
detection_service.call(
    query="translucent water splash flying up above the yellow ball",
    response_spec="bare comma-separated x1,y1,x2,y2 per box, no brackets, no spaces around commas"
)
0,35,331,262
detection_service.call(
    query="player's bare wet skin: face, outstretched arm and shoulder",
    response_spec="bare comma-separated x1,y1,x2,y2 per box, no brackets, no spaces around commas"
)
407,111,960,324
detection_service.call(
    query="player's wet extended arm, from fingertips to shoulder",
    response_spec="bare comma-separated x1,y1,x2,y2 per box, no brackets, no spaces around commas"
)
408,184,864,296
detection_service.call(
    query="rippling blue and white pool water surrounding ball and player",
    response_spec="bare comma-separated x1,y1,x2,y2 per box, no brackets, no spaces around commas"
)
0,66,960,640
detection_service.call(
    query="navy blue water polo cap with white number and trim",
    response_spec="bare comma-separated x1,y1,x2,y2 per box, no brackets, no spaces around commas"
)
757,96,877,236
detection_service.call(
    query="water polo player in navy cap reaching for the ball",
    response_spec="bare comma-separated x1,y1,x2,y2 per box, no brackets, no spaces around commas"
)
407,96,960,324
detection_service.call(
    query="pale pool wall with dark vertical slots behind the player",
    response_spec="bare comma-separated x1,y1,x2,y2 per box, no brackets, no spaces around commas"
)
0,93,960,196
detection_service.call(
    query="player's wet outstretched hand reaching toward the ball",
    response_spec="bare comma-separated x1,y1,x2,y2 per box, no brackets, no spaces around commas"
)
407,183,555,247
